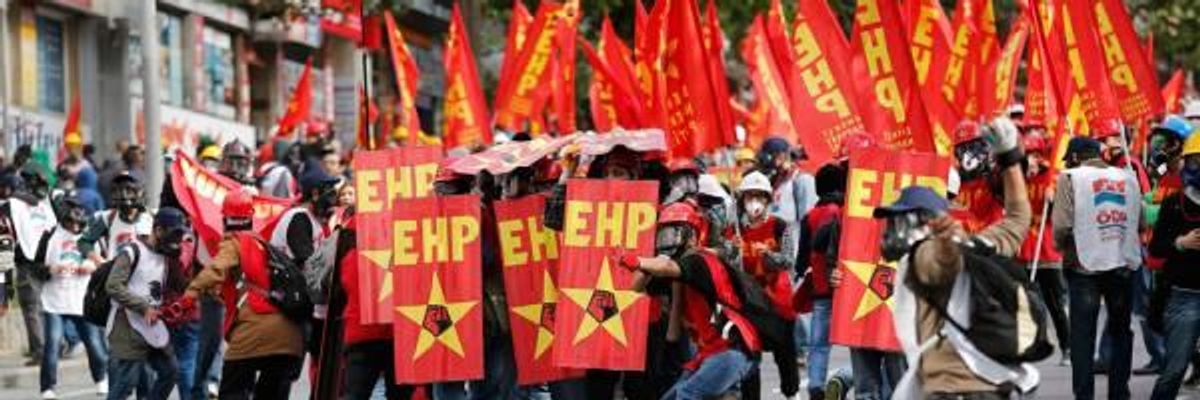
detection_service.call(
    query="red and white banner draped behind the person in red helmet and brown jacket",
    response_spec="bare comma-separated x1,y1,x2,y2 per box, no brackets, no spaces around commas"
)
170,149,295,261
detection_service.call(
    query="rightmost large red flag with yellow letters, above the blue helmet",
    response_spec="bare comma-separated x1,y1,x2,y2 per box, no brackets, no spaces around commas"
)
1092,0,1163,125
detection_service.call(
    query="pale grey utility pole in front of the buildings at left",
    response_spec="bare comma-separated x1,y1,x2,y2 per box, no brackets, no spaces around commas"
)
140,0,164,209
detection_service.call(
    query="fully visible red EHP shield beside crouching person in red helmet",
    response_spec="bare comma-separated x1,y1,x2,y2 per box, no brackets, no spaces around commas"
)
554,179,659,370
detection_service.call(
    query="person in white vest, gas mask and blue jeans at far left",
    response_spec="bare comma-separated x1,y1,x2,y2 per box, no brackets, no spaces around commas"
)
41,197,108,399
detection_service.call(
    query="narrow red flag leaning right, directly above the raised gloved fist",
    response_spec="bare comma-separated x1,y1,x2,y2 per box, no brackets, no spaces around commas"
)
979,18,1028,119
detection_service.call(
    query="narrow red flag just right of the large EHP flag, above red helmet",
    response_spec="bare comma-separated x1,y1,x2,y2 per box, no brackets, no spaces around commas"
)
907,0,960,155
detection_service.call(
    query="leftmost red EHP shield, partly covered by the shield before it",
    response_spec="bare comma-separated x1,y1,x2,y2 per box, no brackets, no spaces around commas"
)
353,147,442,323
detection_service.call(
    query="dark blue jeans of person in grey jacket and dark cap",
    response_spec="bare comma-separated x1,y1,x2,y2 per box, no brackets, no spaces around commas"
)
108,350,179,400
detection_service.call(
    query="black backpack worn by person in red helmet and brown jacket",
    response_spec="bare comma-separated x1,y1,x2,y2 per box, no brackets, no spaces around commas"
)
256,238,312,322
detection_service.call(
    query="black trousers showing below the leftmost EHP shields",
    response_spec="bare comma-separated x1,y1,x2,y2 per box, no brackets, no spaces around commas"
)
343,340,414,400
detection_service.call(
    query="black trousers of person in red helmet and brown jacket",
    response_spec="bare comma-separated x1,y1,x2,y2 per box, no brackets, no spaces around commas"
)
220,356,304,400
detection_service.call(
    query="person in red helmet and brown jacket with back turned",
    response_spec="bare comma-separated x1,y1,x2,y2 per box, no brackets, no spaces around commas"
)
186,190,311,399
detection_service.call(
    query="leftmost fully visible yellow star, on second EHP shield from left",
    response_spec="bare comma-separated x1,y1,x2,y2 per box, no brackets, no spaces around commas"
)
396,271,479,360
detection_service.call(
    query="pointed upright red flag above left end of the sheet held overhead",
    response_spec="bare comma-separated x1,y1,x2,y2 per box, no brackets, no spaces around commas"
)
442,2,492,149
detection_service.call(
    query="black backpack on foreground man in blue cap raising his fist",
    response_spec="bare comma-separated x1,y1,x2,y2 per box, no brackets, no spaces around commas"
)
914,238,1054,365
